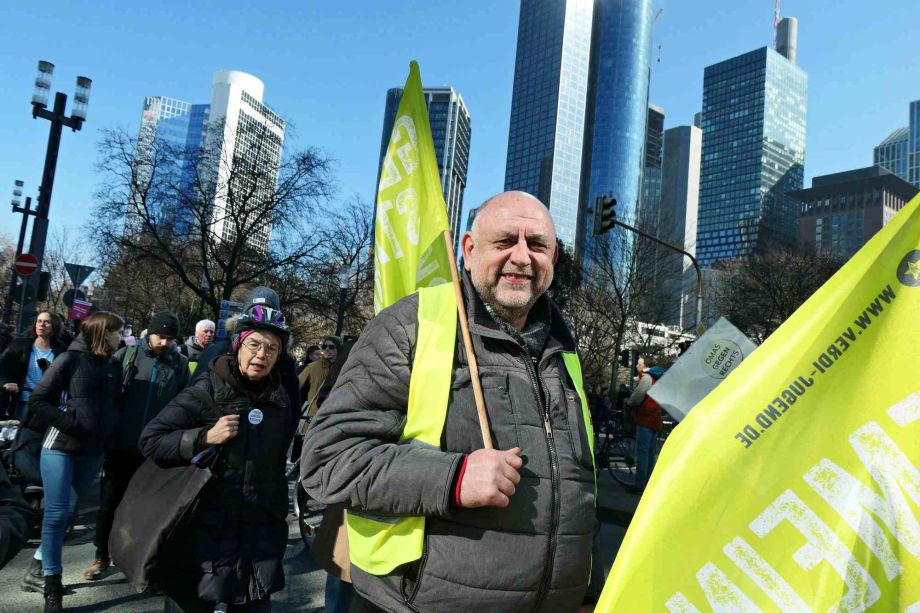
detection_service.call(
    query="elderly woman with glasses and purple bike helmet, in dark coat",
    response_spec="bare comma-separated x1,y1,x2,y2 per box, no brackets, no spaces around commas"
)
140,305,291,613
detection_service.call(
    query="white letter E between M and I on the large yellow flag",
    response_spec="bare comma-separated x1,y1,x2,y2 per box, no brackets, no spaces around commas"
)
751,490,881,611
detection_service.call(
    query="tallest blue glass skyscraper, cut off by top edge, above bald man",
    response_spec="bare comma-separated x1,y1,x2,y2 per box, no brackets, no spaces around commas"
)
505,0,654,254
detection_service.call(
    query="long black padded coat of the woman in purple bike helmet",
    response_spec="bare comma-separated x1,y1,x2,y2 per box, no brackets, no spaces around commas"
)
140,356,291,604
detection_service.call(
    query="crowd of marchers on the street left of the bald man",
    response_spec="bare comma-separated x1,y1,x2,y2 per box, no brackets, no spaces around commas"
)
0,287,352,612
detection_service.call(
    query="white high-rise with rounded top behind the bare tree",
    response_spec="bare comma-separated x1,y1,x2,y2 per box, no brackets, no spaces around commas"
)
208,70,284,252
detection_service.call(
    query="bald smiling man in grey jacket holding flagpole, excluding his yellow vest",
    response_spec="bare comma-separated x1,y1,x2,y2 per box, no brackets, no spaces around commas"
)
301,192,598,613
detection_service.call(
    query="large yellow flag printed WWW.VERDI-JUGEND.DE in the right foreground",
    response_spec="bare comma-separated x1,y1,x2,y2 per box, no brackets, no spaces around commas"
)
597,196,920,613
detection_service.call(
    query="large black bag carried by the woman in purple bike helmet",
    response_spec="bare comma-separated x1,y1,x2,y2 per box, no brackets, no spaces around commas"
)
109,388,221,592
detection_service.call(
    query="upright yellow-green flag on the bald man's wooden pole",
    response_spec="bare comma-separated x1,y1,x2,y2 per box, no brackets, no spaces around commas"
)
374,62,451,313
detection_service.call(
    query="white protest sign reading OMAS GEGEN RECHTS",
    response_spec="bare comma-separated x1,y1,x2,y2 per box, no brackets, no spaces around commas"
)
648,317,757,421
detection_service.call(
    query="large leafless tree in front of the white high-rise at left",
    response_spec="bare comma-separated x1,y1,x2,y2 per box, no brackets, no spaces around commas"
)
88,117,332,318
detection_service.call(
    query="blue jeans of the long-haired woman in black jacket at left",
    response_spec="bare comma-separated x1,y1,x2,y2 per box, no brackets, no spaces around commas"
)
41,447,102,575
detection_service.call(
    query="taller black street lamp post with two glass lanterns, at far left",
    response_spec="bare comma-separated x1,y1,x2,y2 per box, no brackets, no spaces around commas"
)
20,61,93,322
